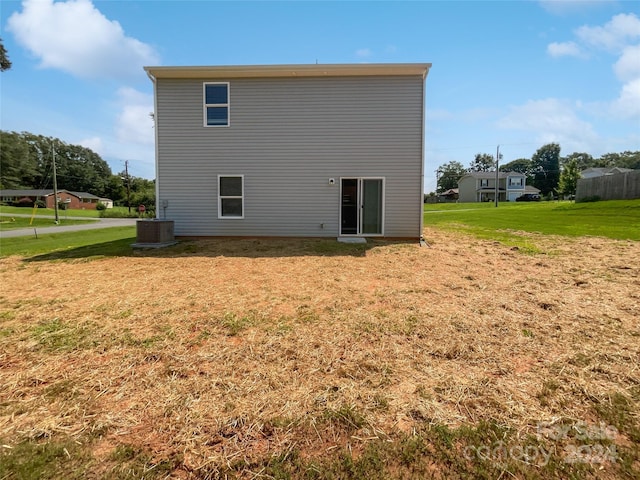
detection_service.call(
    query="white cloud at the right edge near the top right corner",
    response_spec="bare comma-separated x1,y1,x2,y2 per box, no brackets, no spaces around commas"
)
576,13,640,52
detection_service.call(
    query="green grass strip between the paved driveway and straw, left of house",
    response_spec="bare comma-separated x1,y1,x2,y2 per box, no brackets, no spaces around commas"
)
0,227,136,260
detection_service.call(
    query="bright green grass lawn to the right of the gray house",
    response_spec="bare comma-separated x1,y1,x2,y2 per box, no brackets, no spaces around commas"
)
424,199,640,241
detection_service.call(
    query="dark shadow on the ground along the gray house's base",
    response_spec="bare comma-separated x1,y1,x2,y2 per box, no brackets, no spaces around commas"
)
24,237,419,262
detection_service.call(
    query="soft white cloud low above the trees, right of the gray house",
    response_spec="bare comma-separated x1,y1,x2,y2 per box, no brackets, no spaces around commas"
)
498,98,598,151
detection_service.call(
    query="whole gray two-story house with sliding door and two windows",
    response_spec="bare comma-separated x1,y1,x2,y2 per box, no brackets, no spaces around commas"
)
145,64,431,239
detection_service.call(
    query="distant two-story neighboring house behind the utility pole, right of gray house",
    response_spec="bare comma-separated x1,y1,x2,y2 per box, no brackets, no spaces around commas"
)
458,172,527,202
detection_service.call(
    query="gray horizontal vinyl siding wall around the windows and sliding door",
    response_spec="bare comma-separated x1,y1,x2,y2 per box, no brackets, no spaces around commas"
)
156,76,424,238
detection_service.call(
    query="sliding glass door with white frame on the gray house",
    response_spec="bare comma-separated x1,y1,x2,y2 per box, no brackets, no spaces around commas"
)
340,178,384,235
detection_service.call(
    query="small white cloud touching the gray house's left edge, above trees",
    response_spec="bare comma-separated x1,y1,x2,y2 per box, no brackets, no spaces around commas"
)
115,87,154,145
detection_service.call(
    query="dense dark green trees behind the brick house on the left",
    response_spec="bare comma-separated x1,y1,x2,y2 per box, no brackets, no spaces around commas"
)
0,130,155,207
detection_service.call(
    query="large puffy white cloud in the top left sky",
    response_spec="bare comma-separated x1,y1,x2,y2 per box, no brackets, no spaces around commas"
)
7,0,159,79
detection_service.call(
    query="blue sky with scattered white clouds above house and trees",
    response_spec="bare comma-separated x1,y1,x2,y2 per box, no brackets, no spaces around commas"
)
0,0,640,192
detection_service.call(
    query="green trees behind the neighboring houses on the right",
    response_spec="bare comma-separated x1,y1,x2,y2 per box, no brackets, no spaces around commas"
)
437,143,640,195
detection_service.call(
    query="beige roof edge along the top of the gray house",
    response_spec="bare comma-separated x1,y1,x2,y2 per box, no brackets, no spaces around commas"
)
144,63,431,79
